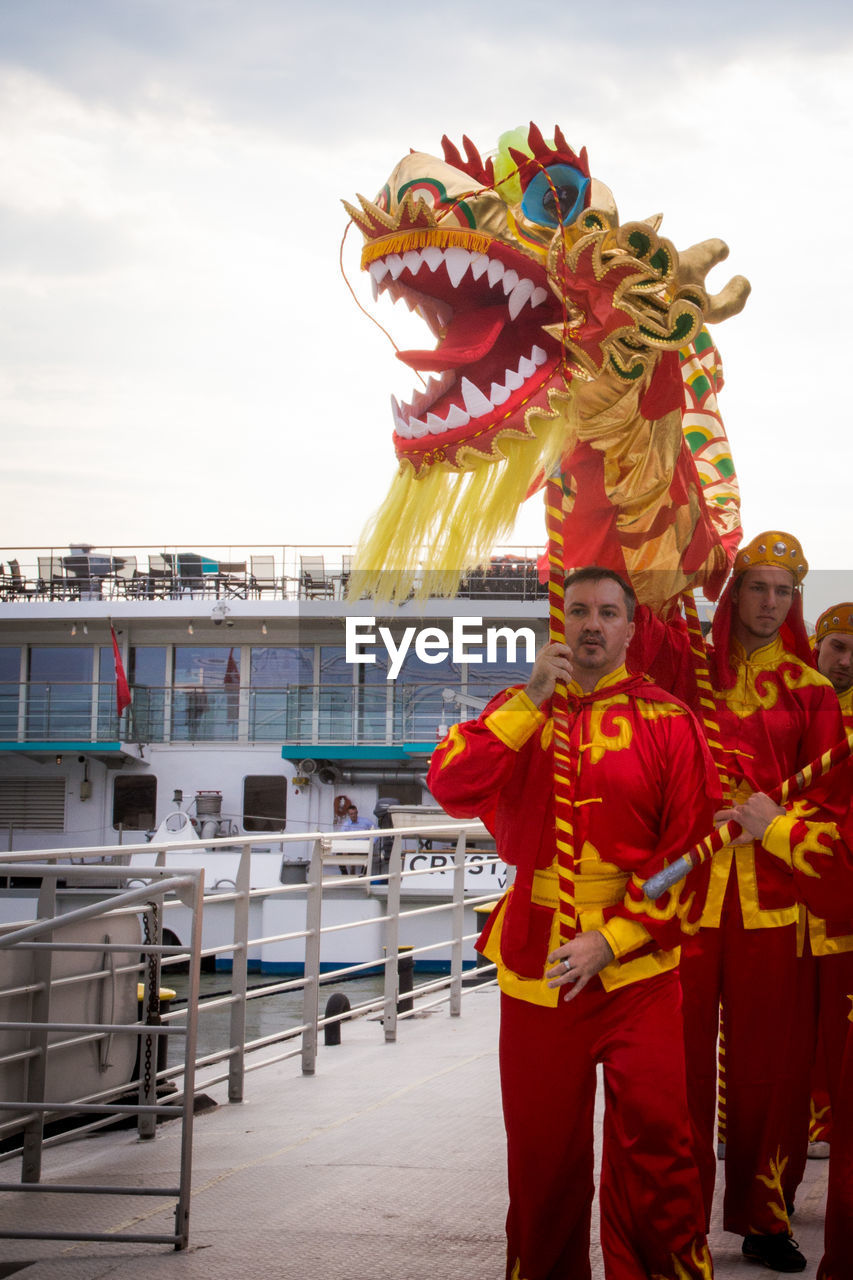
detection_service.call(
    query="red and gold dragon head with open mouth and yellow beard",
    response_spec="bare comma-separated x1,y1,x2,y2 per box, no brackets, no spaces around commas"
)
346,124,749,607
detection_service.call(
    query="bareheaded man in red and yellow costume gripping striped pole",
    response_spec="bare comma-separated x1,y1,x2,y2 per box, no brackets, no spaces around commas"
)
428,567,719,1280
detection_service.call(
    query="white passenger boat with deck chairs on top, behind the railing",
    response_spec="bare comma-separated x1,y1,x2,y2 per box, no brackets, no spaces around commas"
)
0,544,547,969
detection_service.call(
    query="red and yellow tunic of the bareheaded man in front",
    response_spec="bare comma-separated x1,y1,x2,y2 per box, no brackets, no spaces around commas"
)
428,667,719,1007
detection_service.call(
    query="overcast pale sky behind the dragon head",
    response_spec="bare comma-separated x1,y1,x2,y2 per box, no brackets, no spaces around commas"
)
0,0,853,614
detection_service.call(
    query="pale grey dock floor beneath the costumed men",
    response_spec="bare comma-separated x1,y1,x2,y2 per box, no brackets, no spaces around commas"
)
0,987,827,1280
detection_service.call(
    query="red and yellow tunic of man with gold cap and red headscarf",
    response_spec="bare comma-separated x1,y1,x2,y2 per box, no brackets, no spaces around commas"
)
702,636,843,929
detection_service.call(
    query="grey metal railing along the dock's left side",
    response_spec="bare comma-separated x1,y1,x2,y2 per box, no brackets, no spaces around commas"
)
0,822,496,1248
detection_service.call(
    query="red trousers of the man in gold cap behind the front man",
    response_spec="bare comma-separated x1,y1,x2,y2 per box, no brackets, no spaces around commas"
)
681,896,802,1235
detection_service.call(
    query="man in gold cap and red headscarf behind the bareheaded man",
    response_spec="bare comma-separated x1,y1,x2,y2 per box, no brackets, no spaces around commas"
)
629,531,843,1272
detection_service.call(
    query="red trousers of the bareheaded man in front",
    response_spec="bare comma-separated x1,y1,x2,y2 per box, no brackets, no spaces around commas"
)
501,973,713,1280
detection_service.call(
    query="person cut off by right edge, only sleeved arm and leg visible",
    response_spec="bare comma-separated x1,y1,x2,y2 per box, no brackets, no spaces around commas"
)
712,788,853,1280
